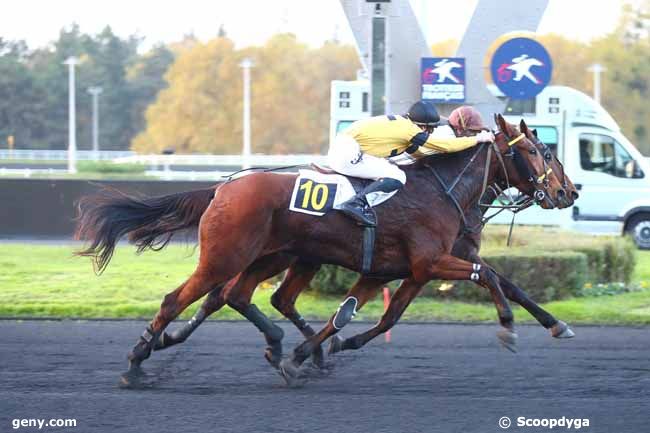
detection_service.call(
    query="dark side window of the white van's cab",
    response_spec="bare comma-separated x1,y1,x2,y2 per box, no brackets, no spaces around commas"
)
580,134,644,178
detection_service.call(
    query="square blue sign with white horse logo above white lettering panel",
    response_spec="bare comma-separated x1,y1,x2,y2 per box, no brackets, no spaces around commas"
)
420,57,465,103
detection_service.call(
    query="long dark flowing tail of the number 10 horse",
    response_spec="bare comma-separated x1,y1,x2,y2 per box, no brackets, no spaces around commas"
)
75,187,215,273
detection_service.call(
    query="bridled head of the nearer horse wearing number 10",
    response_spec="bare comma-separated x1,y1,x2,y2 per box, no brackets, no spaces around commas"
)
495,114,564,209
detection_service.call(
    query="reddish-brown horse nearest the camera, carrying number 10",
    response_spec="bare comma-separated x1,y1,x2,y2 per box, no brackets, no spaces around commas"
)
78,116,562,383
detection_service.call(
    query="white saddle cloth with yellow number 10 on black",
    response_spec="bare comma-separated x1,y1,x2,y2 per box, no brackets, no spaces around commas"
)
289,169,397,216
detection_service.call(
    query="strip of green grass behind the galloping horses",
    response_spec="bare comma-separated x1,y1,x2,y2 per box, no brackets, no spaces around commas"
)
0,244,650,324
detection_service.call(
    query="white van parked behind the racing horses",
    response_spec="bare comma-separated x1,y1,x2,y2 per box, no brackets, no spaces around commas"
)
330,80,650,249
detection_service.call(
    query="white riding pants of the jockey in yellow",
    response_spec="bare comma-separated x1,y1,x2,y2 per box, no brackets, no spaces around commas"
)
327,134,406,184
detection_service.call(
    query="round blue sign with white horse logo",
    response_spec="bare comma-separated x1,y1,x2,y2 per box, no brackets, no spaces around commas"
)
490,38,553,99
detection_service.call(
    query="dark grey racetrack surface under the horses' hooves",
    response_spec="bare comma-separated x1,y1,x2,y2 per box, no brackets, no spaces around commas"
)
0,320,650,433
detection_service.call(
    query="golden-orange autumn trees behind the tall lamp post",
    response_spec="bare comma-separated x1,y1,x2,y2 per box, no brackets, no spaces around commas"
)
133,34,359,153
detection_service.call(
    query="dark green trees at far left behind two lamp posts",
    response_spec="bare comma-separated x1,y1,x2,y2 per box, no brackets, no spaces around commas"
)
0,24,173,150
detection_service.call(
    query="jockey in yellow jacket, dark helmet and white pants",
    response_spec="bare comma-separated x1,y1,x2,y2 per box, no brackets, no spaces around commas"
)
327,101,494,226
